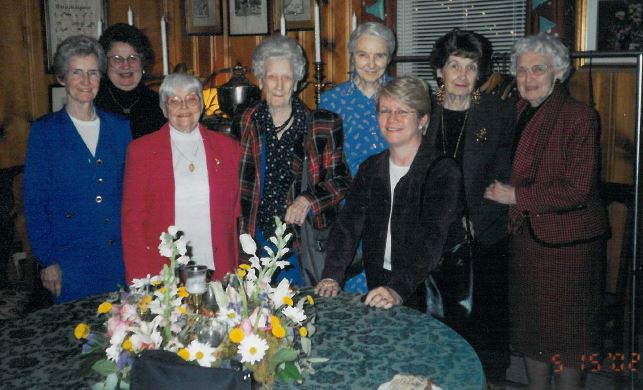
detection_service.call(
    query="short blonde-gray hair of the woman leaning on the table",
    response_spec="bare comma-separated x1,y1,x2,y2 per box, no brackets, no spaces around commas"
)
377,75,431,134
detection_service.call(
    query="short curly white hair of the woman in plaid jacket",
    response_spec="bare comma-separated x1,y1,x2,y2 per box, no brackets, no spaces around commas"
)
252,35,306,83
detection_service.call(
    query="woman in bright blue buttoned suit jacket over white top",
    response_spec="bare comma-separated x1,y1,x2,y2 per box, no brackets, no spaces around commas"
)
24,36,131,303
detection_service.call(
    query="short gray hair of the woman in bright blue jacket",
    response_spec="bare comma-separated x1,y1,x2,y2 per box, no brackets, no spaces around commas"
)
54,35,107,80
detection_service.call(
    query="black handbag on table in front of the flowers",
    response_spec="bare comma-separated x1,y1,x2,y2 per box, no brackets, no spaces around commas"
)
130,350,252,390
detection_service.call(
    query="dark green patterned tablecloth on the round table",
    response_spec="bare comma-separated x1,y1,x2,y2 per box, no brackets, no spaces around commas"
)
0,294,484,390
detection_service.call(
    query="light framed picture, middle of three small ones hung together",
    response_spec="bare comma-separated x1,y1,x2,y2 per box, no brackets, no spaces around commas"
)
228,0,270,36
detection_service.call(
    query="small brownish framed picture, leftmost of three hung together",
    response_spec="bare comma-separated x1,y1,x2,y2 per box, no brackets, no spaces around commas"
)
185,0,223,35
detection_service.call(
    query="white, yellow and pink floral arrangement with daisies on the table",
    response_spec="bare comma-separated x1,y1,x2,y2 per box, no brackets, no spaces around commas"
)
74,218,326,389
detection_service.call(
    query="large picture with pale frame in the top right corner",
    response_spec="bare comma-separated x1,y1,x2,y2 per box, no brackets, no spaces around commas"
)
576,0,643,64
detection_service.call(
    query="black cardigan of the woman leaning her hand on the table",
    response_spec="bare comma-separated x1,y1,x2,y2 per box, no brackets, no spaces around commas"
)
323,141,462,311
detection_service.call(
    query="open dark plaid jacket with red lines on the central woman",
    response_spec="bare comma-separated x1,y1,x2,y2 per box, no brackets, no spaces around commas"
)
233,98,351,235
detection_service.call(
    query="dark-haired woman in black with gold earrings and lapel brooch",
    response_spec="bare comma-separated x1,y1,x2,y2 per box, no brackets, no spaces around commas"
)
427,29,515,382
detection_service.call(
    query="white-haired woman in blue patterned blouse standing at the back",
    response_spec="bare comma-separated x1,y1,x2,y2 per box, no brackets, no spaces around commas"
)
319,22,395,293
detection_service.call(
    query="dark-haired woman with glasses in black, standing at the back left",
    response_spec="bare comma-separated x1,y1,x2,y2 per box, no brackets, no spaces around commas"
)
96,23,165,138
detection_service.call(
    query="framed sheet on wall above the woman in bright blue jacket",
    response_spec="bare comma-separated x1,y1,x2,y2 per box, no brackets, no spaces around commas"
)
41,0,107,73
